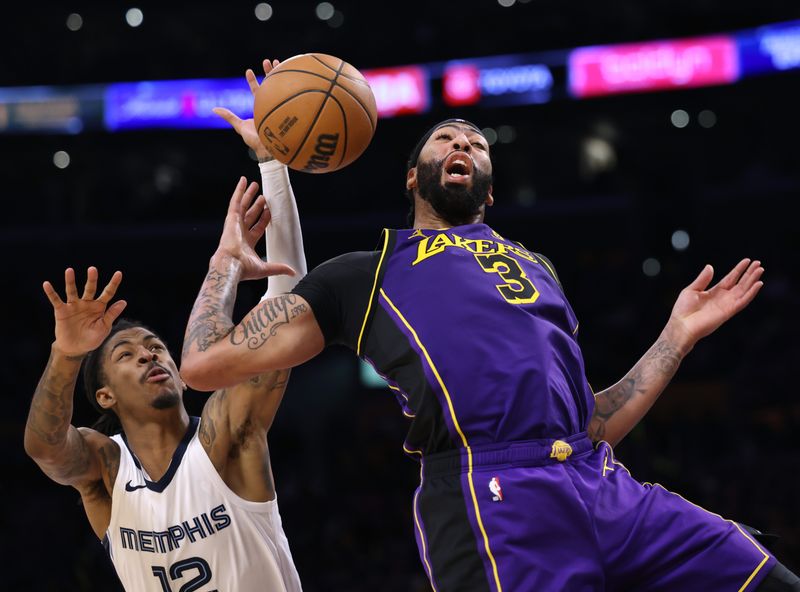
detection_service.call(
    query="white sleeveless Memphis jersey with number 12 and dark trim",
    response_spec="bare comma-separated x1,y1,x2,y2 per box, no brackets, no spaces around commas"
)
103,417,301,592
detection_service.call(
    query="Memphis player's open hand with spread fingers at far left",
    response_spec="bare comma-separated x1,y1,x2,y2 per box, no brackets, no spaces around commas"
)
42,267,128,356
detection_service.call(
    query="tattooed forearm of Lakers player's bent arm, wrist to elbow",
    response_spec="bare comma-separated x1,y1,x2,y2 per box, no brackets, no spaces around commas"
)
183,258,238,356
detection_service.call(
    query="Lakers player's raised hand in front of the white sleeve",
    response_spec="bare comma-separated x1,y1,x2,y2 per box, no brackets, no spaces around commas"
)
217,177,295,280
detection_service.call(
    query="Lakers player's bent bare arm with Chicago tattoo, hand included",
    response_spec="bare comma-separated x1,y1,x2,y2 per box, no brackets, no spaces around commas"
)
181,177,324,391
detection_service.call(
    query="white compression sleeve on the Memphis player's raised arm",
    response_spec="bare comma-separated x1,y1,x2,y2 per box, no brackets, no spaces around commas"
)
258,160,308,300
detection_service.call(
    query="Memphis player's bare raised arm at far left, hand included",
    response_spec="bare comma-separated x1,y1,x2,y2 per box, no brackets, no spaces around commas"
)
25,267,126,489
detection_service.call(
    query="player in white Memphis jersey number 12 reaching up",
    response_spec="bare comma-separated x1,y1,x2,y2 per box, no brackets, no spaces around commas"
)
25,62,305,592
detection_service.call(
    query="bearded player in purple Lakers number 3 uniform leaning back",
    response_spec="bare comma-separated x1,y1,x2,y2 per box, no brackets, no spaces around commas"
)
182,119,800,592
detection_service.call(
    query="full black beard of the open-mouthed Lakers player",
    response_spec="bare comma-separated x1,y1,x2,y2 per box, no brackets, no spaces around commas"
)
417,160,492,226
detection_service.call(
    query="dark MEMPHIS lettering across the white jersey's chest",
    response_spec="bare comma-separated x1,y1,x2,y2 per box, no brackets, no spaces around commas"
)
119,504,231,553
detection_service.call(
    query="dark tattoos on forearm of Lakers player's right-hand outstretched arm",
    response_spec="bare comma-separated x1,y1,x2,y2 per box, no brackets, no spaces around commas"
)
588,340,681,442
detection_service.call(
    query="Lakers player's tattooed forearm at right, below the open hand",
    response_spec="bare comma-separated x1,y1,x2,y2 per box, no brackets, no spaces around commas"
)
587,339,682,441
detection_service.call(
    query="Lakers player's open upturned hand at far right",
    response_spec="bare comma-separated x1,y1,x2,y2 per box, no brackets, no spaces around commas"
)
670,259,764,347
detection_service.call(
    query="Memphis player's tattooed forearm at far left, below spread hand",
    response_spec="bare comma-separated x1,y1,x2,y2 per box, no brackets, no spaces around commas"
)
25,352,82,447
